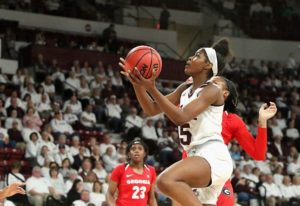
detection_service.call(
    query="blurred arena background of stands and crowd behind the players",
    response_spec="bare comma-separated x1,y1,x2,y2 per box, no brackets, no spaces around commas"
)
0,0,300,206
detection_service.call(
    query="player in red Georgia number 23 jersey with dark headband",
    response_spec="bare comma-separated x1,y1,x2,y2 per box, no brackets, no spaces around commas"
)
106,140,157,206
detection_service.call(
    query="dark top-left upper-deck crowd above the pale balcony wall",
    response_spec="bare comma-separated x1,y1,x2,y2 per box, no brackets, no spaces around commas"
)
0,0,126,22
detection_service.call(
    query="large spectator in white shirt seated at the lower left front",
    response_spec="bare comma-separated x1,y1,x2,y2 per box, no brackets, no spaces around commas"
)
26,166,54,206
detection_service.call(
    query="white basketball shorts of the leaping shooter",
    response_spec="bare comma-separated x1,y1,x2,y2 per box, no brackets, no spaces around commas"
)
187,140,233,205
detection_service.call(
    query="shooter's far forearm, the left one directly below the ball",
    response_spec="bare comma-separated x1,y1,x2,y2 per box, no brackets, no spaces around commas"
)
133,86,162,116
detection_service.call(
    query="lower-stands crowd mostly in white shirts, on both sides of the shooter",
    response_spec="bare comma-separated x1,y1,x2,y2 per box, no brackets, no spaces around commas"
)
0,40,300,206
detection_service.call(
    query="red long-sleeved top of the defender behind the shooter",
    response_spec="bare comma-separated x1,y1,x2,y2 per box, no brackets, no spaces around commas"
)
182,111,267,160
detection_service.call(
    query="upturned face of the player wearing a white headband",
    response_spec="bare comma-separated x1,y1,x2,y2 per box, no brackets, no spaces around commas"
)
184,50,211,76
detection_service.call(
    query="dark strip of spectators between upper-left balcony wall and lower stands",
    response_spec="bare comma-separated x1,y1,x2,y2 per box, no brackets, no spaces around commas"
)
0,20,143,60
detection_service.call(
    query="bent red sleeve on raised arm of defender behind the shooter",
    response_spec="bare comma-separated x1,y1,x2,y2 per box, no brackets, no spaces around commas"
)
234,116,267,160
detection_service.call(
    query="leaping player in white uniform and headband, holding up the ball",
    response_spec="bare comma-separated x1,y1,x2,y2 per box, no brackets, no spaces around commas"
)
120,39,232,206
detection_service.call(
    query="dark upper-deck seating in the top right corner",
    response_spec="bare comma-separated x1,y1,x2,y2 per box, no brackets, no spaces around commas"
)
209,0,300,40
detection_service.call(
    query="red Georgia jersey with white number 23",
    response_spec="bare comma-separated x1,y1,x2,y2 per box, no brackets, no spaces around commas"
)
111,164,156,206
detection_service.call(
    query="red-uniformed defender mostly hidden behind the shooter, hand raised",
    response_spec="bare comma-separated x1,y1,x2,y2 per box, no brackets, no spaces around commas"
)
173,76,277,206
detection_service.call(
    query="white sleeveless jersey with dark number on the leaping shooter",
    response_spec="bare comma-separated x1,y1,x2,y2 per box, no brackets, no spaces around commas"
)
178,85,224,150
